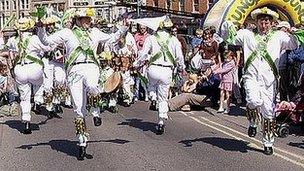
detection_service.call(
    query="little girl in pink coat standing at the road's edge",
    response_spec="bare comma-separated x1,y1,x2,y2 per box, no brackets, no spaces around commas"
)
214,51,236,113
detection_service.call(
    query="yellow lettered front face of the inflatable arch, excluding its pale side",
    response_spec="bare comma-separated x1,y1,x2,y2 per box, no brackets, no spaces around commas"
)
225,0,304,24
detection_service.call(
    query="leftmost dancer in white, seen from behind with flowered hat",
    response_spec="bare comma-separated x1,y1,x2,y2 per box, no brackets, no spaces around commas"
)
14,18,52,134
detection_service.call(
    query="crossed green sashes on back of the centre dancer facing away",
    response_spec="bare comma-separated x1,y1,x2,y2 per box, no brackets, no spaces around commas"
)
149,33,176,66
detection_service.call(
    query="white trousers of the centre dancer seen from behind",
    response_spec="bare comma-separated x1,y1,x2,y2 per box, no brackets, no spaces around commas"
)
147,65,172,122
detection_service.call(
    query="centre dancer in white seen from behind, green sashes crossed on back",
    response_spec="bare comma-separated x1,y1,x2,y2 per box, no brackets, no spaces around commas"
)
138,17,185,134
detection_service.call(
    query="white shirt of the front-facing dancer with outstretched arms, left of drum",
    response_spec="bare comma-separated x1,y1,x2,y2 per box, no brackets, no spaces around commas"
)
38,28,124,62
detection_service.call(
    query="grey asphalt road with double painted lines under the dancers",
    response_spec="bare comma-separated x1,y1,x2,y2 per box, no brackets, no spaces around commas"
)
0,102,304,171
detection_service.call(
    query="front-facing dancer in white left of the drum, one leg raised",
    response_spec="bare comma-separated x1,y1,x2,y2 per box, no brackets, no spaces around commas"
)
38,8,124,160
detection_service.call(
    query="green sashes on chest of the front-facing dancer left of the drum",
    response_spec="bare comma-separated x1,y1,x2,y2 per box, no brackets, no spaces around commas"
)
64,27,98,69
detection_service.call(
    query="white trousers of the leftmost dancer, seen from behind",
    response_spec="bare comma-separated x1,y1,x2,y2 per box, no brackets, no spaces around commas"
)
14,63,43,121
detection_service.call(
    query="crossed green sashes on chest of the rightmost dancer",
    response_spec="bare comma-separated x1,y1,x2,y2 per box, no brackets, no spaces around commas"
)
244,31,279,78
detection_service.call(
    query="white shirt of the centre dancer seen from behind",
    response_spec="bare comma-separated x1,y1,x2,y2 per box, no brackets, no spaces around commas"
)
138,31,185,70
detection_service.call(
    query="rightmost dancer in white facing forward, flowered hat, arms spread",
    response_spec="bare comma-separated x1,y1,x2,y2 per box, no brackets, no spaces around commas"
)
222,7,298,155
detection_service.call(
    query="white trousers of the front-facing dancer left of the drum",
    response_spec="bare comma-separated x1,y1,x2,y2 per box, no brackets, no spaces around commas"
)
68,64,100,118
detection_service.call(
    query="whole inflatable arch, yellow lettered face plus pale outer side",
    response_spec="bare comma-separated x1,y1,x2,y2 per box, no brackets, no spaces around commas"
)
204,0,304,28
